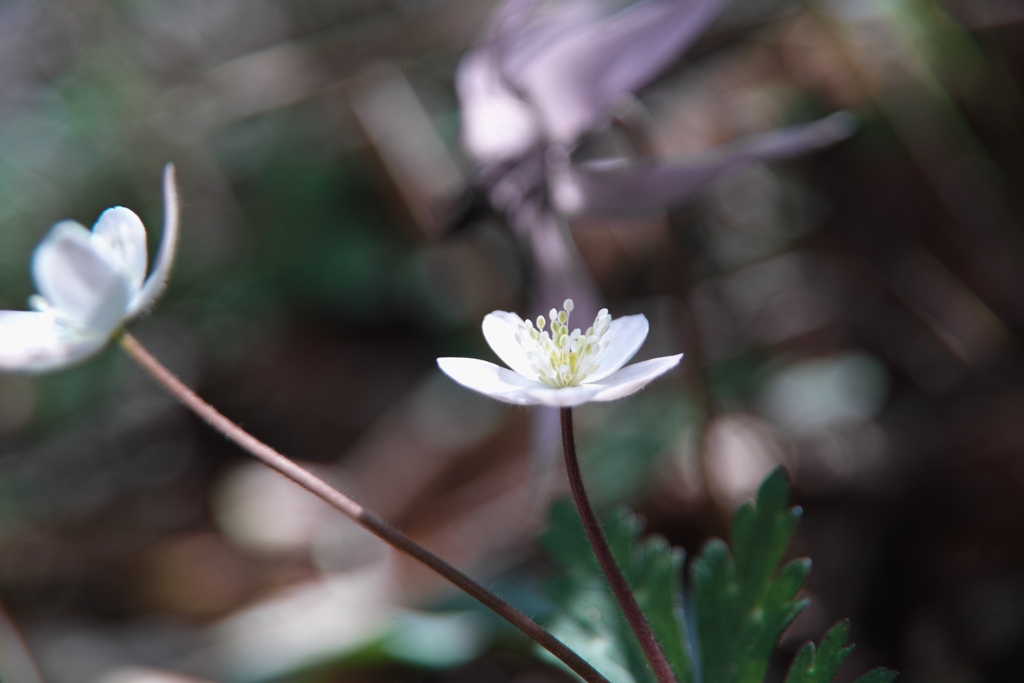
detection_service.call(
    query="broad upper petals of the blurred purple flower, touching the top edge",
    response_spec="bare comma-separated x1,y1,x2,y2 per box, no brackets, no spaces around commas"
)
456,0,725,157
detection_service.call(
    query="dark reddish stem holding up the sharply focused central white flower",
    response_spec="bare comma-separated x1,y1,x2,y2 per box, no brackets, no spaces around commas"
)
561,408,676,683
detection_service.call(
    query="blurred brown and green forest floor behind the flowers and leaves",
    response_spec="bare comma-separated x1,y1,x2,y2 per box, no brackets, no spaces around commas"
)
0,0,1024,683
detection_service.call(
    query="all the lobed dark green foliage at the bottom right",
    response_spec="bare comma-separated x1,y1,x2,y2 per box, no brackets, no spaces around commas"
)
542,469,896,683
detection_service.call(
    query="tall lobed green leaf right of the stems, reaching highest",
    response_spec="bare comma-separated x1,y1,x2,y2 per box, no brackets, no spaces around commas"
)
690,469,811,683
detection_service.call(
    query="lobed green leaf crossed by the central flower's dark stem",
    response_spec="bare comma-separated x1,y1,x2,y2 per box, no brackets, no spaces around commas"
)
541,501,694,683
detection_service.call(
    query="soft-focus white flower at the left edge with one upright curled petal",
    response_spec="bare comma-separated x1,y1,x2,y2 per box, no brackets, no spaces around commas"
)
0,164,178,372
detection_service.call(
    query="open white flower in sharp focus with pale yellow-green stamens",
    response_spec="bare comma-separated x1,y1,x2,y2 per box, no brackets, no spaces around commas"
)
437,299,683,408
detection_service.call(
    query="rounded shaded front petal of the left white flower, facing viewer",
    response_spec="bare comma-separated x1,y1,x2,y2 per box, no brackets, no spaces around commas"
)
32,221,129,333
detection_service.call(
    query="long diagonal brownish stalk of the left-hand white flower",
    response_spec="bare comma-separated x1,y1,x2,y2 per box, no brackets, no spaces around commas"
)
121,333,608,683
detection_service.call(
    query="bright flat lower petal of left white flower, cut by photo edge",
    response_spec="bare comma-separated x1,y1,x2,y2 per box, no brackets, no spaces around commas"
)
0,310,108,373
